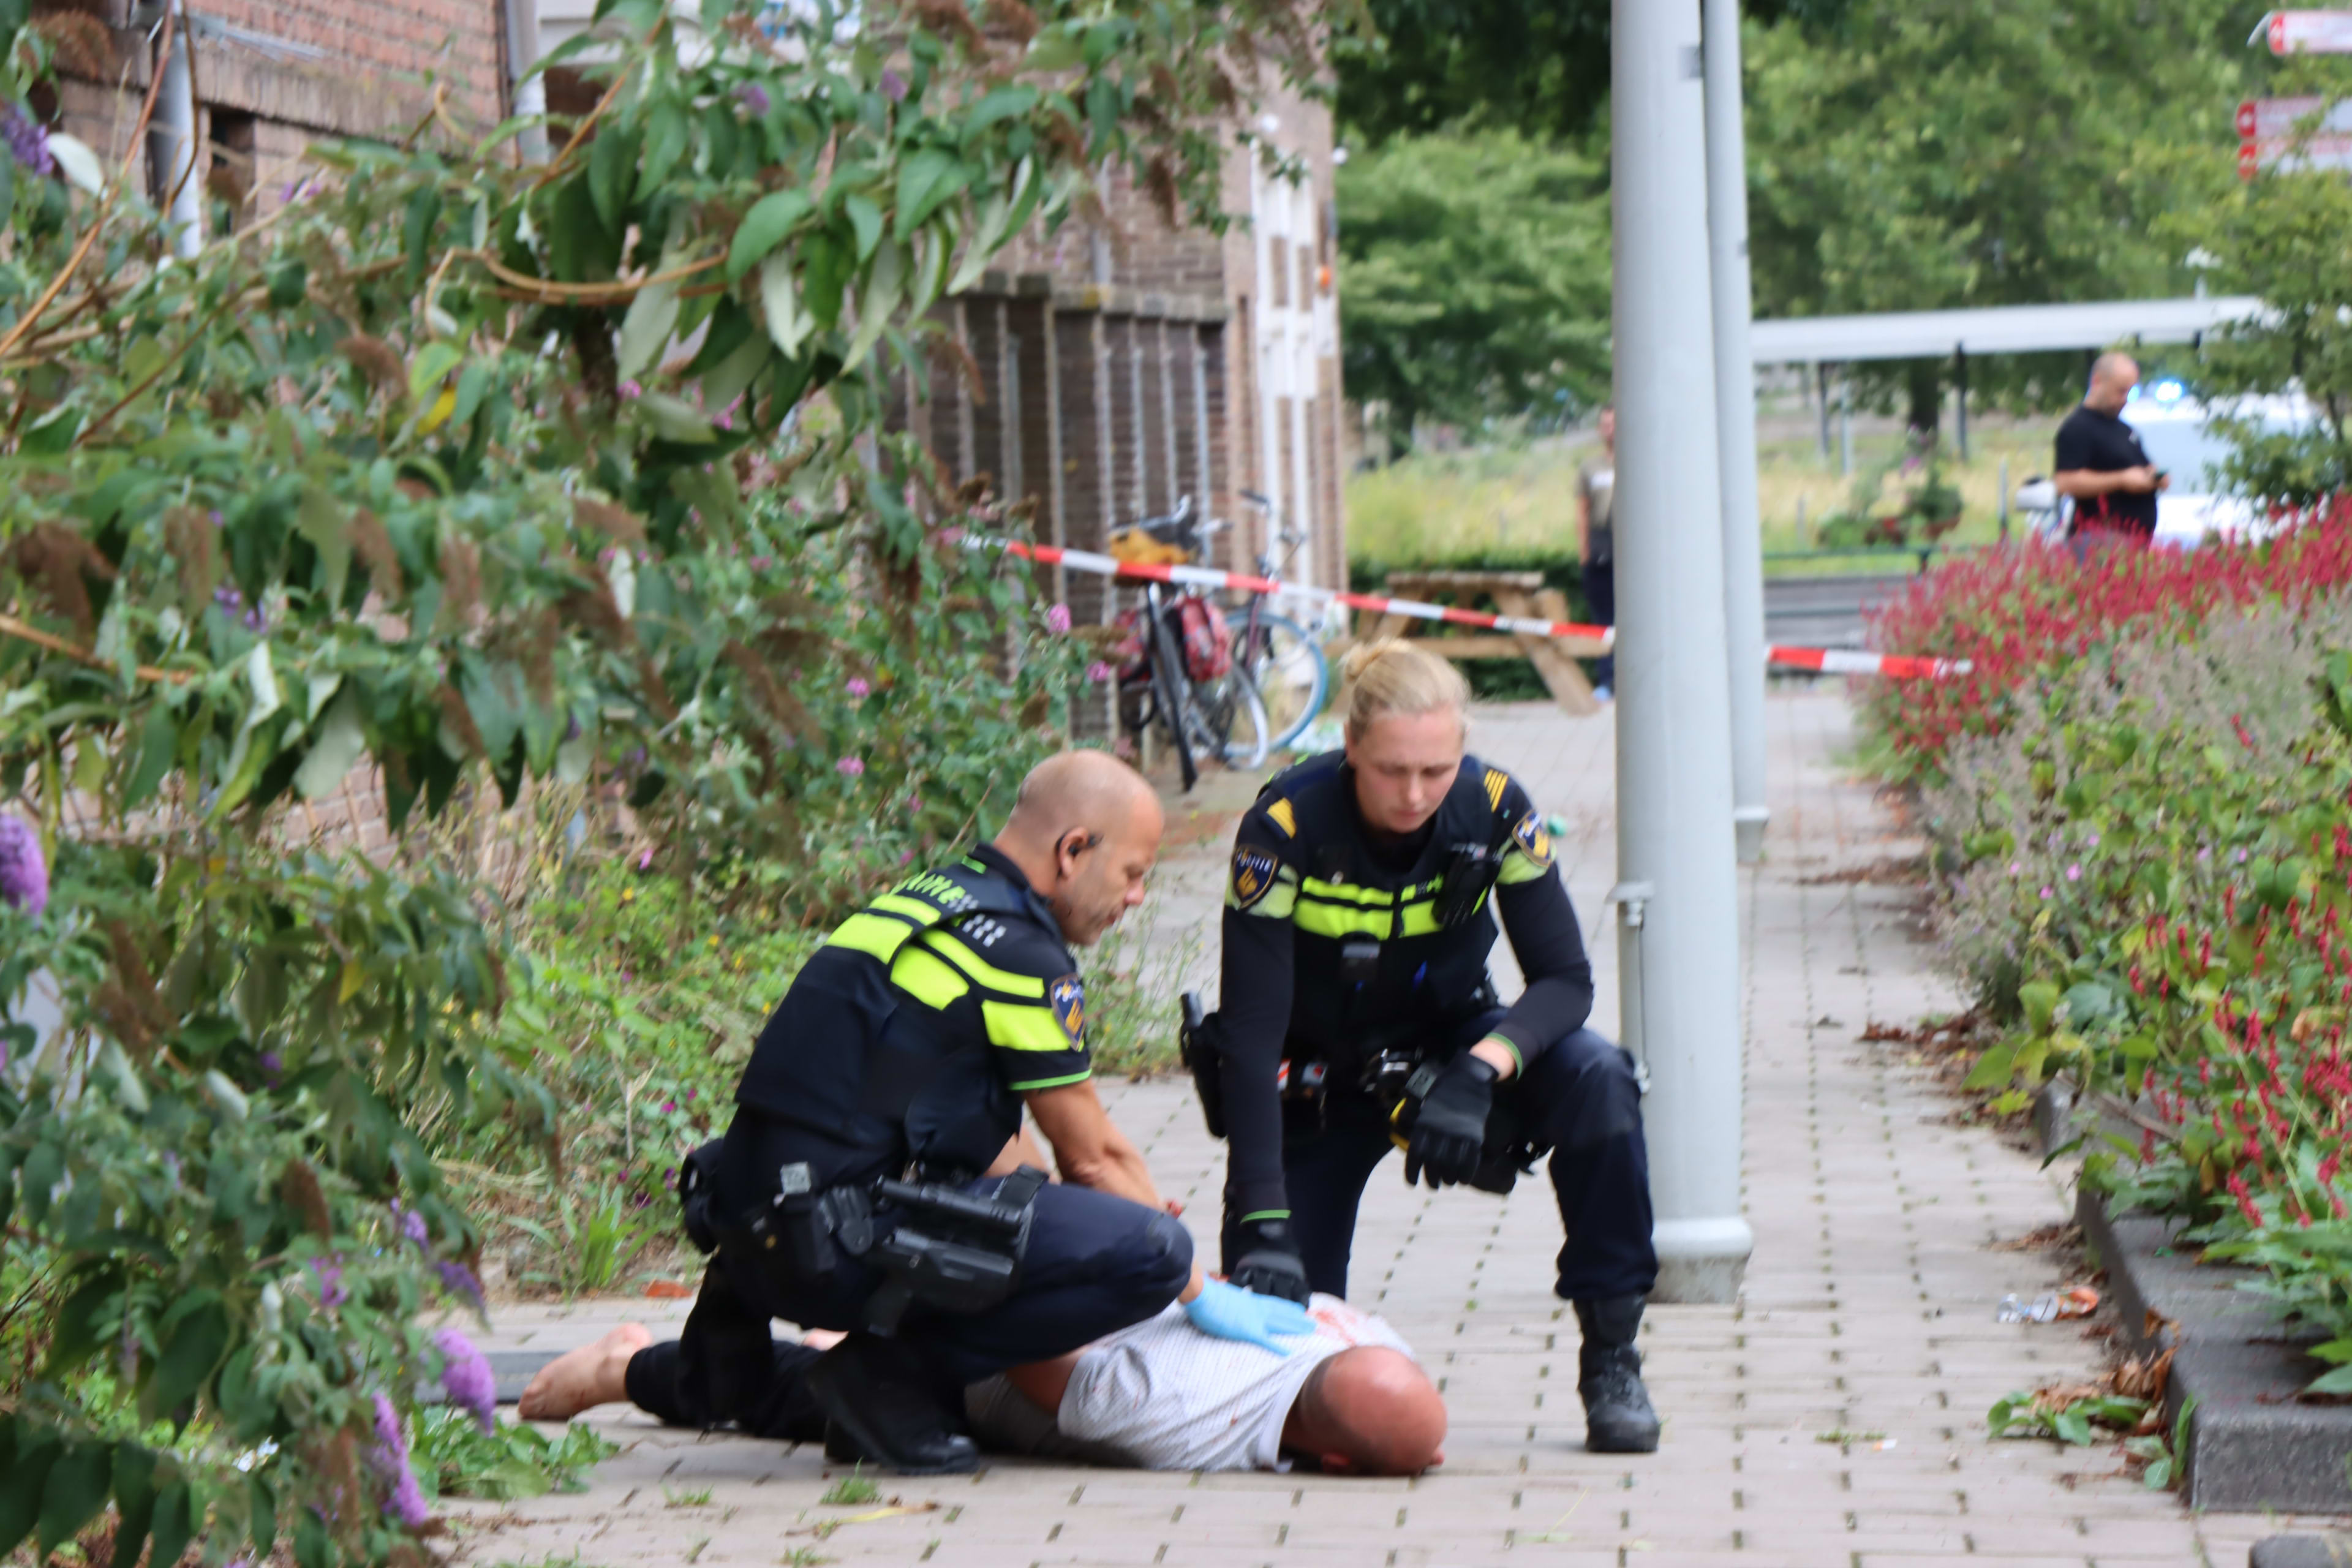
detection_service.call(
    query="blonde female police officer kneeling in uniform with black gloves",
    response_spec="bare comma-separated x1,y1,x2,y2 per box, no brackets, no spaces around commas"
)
1195,639,1658,1453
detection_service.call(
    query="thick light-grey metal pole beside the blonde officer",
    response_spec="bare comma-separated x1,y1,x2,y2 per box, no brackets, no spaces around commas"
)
1609,0,1755,1302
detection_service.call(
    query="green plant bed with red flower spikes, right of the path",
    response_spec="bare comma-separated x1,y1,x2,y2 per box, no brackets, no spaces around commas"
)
1926,597,2352,1392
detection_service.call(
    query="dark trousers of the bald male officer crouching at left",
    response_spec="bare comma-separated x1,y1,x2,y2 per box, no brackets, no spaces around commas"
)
628,1114,1193,1434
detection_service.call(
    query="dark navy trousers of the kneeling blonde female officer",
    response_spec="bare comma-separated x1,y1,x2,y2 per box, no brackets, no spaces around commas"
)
1270,1009,1658,1300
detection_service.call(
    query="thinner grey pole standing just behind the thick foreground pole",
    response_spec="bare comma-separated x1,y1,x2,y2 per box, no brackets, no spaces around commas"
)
1703,0,1771,865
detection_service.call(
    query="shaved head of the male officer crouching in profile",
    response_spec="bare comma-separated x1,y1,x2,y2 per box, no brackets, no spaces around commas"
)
995,752,1167,948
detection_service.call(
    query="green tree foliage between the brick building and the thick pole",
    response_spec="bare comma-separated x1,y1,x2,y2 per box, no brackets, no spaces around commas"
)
1338,129,1609,444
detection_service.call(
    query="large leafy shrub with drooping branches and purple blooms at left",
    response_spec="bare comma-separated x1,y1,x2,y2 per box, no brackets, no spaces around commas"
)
0,0,1310,1568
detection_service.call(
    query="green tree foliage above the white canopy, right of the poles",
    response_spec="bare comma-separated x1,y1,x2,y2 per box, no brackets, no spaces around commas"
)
1745,0,2260,423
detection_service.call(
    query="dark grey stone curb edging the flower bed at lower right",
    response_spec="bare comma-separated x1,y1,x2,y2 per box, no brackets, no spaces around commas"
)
2075,1189,2352,1523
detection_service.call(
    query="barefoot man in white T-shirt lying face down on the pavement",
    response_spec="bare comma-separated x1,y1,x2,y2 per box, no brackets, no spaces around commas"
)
520,1295,1447,1476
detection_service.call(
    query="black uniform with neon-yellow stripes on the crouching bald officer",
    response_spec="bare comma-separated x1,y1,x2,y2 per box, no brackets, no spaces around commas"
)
628,846,1193,1469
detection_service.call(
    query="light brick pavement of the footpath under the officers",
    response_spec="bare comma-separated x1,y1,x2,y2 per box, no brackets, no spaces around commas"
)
449,693,2342,1568
